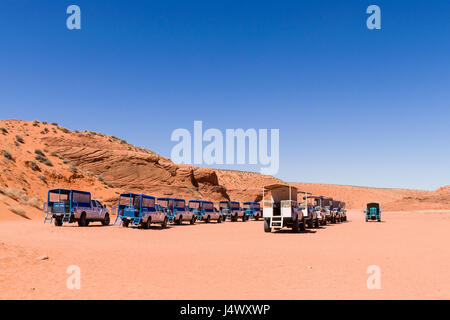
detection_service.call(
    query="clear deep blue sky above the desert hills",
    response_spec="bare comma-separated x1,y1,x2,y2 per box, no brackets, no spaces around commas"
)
0,0,450,189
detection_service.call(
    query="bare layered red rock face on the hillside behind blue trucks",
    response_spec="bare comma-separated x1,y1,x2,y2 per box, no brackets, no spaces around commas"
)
44,136,234,200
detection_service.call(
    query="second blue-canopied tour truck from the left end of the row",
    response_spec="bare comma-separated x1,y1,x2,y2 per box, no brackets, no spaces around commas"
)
114,193,168,229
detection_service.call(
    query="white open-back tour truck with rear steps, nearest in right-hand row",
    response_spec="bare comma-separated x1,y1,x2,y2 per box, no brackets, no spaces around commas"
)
263,184,305,232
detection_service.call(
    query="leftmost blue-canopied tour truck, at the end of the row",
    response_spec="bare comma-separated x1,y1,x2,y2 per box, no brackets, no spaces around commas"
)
43,189,110,227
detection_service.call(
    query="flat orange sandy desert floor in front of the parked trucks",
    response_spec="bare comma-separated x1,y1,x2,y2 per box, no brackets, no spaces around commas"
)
0,211,450,299
